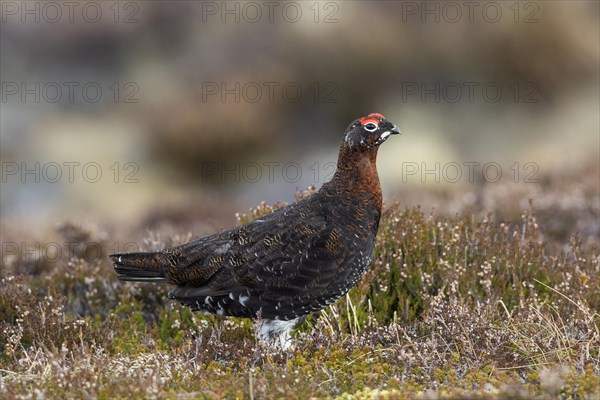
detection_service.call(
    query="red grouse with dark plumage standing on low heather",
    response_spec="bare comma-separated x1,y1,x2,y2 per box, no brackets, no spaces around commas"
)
110,113,400,348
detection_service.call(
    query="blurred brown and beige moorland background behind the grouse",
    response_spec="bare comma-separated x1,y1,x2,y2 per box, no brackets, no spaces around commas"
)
0,1,600,244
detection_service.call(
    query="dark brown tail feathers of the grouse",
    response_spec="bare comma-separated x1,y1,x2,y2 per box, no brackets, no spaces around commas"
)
109,252,167,282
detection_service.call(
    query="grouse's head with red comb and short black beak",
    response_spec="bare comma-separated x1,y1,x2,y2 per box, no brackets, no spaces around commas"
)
342,113,400,152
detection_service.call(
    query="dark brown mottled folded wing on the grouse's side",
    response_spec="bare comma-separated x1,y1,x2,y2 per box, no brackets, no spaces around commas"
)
169,198,366,319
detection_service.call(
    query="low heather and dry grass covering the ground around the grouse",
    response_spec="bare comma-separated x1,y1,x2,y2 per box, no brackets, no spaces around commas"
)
0,161,600,399
